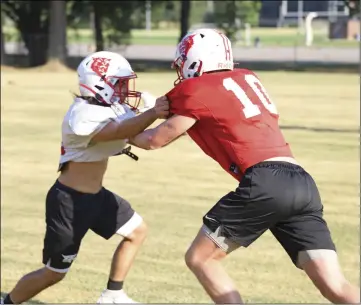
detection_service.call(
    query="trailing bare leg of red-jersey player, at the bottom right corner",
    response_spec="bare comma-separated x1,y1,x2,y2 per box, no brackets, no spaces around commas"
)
302,250,360,304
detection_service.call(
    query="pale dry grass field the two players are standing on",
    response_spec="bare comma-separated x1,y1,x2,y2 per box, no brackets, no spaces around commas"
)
1,70,360,303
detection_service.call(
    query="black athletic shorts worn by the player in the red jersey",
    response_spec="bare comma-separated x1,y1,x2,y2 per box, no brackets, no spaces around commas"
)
203,161,336,265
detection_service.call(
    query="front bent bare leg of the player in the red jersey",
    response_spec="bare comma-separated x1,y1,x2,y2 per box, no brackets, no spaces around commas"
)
185,229,243,304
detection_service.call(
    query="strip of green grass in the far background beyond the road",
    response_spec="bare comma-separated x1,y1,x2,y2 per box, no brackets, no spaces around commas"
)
4,27,359,48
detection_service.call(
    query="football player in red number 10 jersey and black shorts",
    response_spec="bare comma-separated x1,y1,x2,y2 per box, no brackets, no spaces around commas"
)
132,29,360,304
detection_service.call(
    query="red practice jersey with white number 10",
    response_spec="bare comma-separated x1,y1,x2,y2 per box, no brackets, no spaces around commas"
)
166,69,292,181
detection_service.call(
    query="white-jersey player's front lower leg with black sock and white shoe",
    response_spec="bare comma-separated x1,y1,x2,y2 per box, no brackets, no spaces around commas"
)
97,222,147,303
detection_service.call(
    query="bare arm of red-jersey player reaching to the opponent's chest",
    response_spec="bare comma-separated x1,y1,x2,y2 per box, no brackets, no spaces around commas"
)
129,115,197,150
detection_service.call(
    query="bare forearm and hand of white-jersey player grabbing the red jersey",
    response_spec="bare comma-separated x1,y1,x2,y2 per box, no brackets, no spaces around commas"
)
92,97,169,142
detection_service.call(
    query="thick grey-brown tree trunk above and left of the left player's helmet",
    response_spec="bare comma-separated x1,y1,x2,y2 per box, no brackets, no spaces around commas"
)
48,0,67,64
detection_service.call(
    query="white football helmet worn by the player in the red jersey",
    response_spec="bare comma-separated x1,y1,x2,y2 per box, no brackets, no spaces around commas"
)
172,29,234,85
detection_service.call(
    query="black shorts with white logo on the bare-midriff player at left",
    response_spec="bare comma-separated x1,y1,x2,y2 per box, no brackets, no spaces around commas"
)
43,181,136,272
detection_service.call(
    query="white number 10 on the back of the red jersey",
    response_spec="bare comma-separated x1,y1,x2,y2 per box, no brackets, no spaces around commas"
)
223,74,278,119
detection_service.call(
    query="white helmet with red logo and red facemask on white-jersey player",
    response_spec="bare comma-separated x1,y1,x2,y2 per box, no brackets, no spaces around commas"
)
77,51,141,109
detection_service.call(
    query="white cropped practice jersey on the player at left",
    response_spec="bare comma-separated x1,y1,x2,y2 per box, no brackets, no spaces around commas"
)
60,98,135,164
